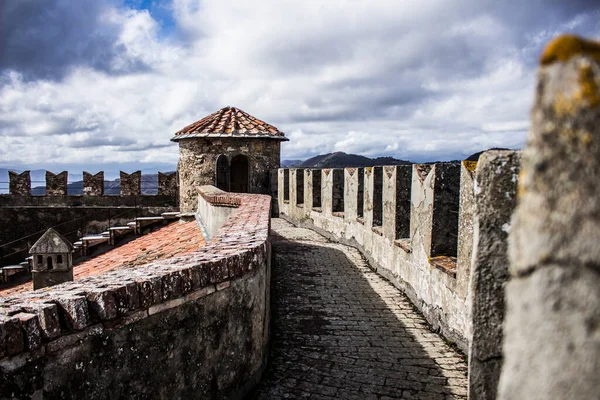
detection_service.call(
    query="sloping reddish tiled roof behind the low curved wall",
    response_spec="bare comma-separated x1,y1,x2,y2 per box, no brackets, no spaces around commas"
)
0,221,206,297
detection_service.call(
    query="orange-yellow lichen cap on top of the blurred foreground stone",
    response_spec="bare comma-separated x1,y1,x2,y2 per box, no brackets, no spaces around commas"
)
540,35,600,65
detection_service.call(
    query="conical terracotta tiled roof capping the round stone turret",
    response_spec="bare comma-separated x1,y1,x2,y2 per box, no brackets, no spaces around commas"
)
171,107,288,142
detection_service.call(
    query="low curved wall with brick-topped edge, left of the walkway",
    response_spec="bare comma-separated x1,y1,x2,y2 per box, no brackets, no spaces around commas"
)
0,188,271,399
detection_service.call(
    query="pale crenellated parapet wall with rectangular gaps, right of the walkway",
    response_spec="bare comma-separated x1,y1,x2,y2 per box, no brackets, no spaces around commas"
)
279,157,516,351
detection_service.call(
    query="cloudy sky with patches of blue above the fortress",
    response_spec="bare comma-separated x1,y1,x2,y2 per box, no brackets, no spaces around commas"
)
0,0,600,175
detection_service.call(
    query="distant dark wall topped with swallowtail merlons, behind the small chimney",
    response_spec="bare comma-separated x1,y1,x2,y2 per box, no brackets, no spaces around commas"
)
0,171,178,265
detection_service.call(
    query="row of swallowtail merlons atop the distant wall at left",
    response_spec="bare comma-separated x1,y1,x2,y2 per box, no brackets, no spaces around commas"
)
0,171,177,197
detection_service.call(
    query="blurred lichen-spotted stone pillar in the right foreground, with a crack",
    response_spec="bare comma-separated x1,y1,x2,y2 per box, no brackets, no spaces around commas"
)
499,36,600,400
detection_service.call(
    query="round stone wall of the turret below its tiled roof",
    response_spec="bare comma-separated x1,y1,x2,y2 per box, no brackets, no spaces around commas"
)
177,138,280,212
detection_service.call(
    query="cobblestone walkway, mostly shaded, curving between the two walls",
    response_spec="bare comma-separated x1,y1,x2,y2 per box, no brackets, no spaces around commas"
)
249,219,467,399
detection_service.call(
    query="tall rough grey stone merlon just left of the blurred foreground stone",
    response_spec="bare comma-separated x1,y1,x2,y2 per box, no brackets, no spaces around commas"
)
468,151,521,400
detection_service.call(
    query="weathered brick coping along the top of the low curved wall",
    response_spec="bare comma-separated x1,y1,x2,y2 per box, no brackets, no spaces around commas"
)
0,186,271,358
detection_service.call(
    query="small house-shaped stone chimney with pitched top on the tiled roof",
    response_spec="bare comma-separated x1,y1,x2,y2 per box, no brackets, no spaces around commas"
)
29,228,73,290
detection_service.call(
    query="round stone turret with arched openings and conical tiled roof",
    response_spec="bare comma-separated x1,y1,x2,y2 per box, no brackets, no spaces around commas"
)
171,107,288,212
